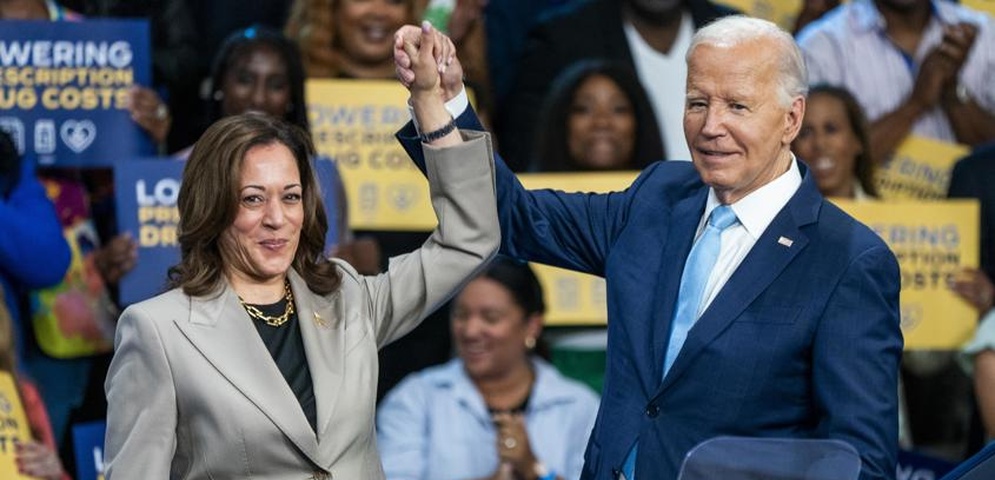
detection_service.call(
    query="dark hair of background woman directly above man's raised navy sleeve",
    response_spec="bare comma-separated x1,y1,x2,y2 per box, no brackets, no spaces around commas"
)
532,60,663,172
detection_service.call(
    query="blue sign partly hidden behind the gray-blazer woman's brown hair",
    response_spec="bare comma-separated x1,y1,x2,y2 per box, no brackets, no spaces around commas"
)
114,158,340,305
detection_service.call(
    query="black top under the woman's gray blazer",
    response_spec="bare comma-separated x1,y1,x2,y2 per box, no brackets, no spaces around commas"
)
249,298,318,432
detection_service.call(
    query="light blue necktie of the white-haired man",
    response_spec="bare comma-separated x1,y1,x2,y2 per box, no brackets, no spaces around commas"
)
622,205,738,480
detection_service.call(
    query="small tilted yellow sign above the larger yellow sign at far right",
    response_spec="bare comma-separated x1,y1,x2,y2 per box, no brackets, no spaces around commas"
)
876,135,970,200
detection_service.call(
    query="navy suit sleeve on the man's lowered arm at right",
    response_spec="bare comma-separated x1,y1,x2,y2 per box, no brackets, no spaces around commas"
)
812,244,903,480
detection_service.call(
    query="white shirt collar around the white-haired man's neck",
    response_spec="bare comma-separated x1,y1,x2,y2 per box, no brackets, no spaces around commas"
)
699,153,802,240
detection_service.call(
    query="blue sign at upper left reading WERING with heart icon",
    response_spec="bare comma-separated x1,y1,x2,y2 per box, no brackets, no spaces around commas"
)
0,20,155,166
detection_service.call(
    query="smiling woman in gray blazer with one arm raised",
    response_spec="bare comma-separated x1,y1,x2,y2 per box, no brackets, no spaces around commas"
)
105,28,500,480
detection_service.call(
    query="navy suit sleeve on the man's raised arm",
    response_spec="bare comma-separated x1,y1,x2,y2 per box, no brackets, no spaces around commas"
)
397,108,632,276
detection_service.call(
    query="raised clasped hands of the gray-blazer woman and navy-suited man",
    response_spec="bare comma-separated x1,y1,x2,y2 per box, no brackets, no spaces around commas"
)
394,22,463,101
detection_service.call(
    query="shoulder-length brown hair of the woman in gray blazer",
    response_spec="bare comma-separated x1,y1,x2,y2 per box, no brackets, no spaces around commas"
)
169,113,341,296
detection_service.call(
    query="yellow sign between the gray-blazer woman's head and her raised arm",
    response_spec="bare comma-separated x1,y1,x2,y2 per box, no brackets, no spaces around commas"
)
306,79,435,231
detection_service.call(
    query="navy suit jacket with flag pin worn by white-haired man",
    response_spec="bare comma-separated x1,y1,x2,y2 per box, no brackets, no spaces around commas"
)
398,109,903,480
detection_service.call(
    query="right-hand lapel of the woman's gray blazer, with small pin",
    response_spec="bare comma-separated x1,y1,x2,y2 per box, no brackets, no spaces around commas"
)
290,271,346,459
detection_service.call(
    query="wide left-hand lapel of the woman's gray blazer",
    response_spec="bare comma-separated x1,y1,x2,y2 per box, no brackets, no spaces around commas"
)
175,284,319,464
